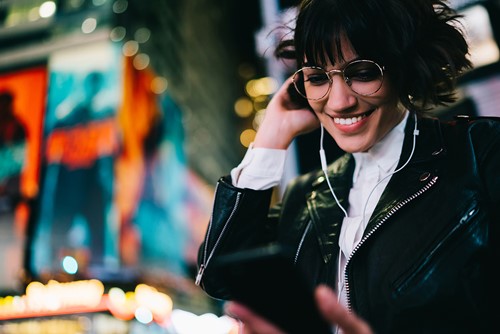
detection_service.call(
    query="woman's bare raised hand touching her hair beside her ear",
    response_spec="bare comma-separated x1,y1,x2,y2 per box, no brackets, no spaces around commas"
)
254,78,319,149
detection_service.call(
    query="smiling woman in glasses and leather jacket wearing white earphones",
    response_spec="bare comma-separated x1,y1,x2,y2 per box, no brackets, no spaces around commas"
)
197,0,500,333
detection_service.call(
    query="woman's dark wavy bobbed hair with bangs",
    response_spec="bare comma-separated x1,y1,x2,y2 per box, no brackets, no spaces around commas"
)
275,0,472,111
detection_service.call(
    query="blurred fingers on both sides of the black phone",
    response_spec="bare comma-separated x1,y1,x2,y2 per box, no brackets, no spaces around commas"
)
225,286,373,334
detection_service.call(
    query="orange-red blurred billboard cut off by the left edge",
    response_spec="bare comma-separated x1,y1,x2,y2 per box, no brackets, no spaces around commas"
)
0,66,47,291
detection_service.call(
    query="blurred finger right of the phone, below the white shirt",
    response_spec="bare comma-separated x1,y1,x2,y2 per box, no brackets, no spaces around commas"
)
315,285,373,334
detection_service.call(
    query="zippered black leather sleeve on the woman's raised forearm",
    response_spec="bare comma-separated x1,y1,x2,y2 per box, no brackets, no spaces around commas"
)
196,176,277,299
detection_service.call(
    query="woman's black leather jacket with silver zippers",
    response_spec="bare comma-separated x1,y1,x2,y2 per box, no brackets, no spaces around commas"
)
198,117,500,334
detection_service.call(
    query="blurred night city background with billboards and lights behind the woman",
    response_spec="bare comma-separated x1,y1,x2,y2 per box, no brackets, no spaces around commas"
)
0,0,500,334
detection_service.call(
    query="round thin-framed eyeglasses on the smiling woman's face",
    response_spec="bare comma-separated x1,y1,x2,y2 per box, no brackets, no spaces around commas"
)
292,59,384,101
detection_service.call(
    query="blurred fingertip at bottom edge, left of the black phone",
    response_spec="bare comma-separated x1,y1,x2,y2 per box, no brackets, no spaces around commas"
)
224,301,284,334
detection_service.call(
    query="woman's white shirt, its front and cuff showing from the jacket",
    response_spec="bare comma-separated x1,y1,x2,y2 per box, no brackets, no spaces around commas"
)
231,112,408,305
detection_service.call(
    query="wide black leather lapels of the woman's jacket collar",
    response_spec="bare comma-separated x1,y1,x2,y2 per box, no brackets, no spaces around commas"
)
307,113,446,263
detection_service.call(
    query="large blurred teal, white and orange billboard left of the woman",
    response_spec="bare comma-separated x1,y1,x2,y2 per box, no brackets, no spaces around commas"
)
28,41,189,282
